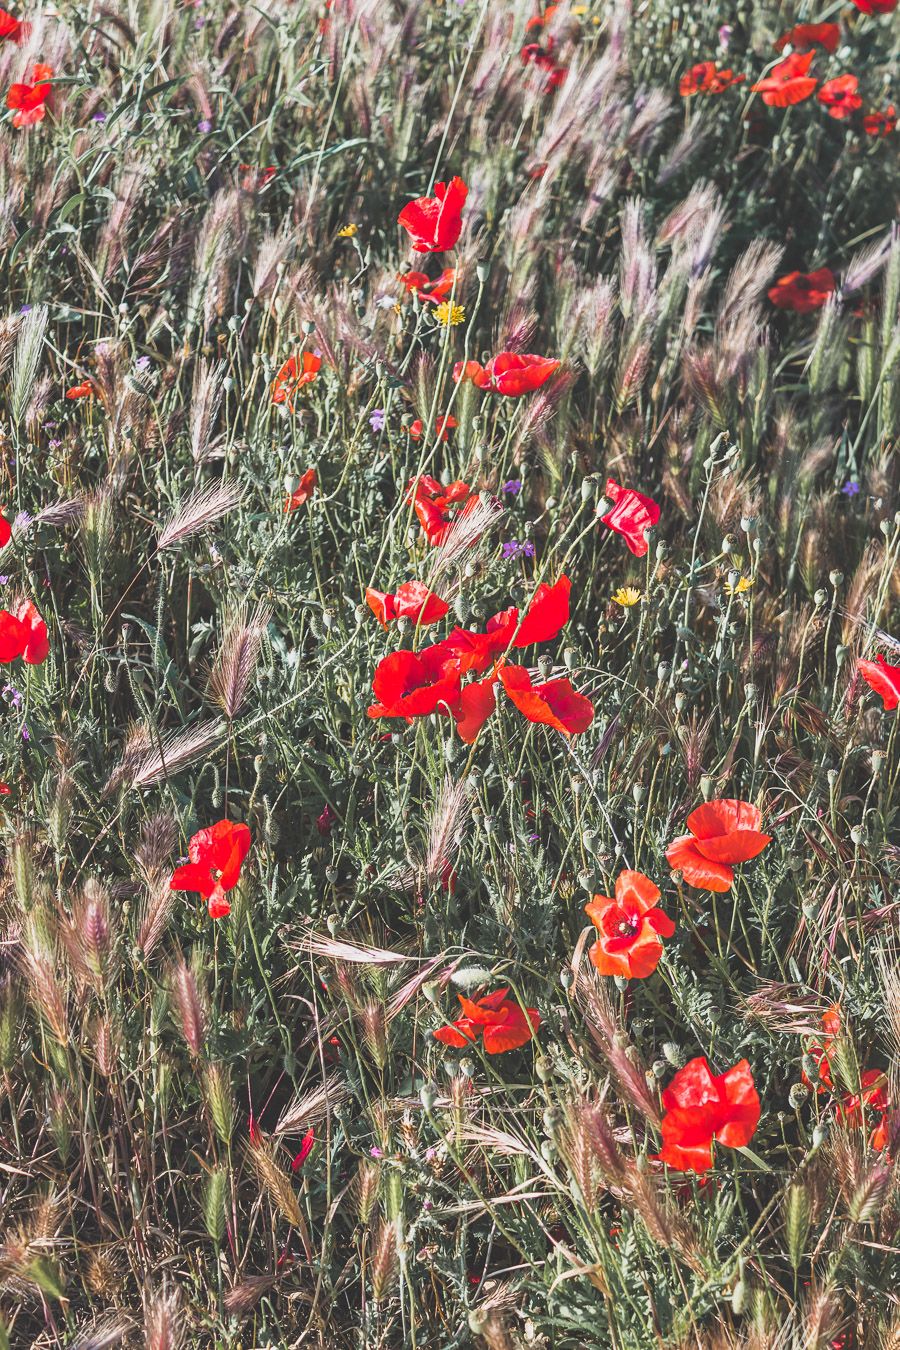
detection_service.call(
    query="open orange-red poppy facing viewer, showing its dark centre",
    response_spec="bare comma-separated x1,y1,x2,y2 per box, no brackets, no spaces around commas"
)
584,871,675,980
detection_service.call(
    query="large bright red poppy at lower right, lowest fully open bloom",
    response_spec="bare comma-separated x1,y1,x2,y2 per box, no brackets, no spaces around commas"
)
657,1056,760,1172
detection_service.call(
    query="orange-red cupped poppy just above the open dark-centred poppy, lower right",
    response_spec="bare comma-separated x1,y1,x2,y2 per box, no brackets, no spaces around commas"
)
665,798,772,892
